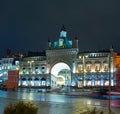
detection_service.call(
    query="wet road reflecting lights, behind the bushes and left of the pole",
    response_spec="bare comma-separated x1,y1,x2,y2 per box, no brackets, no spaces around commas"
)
0,90,120,114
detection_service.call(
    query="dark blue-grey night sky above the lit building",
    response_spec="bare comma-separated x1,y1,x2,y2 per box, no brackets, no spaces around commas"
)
0,0,120,55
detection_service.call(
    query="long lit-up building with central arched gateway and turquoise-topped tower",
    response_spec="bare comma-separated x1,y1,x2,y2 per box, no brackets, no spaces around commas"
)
19,27,116,88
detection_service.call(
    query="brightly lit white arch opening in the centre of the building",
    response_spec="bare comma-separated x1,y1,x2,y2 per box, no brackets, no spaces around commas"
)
51,62,71,87
